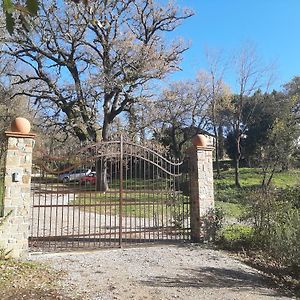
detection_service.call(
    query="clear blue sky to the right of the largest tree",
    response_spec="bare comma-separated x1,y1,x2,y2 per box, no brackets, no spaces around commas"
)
172,0,300,89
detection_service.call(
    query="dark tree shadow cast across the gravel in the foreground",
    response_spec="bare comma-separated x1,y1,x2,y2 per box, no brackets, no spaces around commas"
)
142,267,283,296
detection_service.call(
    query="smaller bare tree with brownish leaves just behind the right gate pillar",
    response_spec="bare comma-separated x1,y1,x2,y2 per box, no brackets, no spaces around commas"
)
143,76,208,158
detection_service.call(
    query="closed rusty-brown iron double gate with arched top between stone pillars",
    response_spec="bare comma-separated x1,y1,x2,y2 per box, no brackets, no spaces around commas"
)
29,138,190,251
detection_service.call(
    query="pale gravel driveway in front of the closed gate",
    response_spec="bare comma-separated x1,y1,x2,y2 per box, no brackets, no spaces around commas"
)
31,244,293,300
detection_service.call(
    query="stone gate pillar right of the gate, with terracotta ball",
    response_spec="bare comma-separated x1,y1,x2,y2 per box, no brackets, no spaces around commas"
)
189,135,214,242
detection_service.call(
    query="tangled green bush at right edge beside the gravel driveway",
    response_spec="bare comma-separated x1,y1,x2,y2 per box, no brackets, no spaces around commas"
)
246,189,300,269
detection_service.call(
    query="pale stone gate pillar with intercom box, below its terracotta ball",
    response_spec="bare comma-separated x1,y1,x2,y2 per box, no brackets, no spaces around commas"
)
0,120,35,258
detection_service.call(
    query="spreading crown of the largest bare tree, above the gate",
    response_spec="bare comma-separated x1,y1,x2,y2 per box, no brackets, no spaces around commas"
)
5,0,192,141
